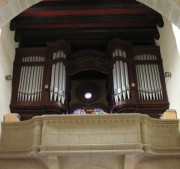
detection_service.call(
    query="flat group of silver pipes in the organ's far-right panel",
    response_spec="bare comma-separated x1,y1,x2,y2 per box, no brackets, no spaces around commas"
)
134,54,163,100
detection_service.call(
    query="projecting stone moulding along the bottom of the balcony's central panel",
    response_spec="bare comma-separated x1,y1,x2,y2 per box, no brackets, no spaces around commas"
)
39,143,144,156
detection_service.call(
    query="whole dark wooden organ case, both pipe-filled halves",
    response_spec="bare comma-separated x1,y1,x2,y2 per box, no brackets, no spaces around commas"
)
10,40,169,120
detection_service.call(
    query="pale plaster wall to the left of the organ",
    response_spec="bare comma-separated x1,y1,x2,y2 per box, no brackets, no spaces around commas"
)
0,24,17,132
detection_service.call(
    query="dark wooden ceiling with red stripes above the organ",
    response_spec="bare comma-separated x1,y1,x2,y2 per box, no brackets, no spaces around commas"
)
10,0,163,50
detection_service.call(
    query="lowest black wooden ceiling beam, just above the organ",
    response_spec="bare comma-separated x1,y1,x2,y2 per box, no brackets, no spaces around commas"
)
15,28,158,42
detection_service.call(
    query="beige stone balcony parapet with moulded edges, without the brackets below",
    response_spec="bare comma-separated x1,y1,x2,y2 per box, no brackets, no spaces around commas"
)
0,114,180,168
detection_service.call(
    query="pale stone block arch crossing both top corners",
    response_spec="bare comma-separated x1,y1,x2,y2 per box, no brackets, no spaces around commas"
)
0,0,180,28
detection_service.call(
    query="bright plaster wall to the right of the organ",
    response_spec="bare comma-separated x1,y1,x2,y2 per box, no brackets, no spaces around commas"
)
157,18,180,118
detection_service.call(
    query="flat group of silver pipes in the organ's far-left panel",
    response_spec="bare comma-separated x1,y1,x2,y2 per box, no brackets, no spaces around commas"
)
17,56,44,102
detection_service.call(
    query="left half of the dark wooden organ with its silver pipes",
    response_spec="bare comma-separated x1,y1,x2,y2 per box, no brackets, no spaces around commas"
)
10,41,70,119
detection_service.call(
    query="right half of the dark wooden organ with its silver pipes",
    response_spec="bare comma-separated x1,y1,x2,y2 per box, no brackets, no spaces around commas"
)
108,39,169,117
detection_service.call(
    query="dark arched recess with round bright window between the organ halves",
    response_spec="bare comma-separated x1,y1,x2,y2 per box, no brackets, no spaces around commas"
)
68,49,109,113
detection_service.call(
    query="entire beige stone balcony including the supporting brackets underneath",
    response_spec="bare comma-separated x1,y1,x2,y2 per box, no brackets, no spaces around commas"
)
0,114,180,169
